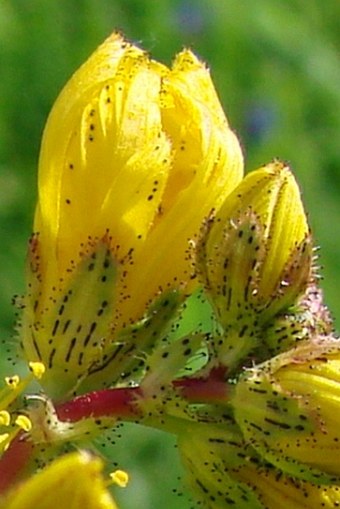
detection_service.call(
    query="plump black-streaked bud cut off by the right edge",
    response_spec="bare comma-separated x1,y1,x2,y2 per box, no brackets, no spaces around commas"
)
231,338,340,484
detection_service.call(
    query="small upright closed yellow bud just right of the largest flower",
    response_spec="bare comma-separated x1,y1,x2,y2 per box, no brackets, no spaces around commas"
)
198,161,312,369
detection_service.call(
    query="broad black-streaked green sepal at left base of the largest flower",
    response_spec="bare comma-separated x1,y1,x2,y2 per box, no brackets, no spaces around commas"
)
21,239,117,400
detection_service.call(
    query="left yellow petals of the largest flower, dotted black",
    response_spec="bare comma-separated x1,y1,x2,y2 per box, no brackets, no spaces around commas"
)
34,34,171,286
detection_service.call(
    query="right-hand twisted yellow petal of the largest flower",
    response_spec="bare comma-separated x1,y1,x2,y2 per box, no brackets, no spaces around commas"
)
115,51,243,334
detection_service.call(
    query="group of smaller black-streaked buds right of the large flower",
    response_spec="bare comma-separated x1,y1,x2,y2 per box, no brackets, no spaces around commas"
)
174,161,340,509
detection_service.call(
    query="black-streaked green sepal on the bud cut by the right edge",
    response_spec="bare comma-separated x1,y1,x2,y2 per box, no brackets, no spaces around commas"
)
231,363,340,485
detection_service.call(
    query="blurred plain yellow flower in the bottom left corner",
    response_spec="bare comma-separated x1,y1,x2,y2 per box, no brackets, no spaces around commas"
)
0,452,117,509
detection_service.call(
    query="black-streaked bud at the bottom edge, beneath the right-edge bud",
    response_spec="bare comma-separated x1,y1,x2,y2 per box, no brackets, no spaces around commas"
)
178,422,340,509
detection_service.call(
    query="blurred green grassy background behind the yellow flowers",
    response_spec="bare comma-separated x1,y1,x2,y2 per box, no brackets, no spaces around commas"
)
0,0,340,509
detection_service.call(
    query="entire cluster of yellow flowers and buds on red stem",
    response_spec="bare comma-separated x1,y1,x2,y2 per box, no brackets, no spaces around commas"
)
0,33,340,509
